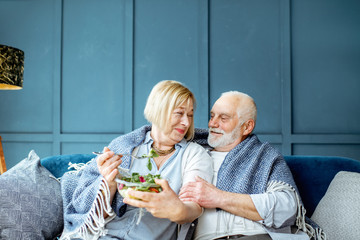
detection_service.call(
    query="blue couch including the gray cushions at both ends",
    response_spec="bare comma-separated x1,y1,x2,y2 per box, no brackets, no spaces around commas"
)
0,151,360,240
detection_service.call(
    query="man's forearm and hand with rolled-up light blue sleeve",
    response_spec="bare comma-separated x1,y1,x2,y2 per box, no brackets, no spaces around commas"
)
180,178,297,227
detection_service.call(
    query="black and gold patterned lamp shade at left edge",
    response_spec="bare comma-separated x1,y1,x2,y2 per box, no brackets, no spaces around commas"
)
0,44,24,90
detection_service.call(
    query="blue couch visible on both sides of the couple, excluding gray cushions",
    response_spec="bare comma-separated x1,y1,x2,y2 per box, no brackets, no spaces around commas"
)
41,154,360,217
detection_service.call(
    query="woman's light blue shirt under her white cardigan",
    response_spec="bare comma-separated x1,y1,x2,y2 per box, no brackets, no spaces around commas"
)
100,132,195,240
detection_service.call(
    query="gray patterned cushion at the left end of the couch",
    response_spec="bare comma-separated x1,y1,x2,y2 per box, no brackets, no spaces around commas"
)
0,151,63,239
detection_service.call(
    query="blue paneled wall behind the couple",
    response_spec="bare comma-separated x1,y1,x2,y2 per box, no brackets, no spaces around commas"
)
0,0,360,168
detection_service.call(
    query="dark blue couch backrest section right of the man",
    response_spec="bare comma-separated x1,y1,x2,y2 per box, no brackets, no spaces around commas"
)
285,156,360,217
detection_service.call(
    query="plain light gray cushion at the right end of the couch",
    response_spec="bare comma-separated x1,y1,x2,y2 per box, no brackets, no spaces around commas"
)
311,171,360,240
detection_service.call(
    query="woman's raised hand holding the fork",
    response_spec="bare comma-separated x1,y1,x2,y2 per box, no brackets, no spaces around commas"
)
96,147,122,197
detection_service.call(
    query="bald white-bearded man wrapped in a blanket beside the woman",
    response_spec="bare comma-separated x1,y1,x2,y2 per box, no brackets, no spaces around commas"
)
180,91,316,240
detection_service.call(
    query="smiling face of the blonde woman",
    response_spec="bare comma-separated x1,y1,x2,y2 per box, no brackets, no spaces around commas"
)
165,99,194,143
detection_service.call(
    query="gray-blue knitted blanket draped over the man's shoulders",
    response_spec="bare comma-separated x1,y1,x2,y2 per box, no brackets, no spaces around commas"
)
194,129,326,239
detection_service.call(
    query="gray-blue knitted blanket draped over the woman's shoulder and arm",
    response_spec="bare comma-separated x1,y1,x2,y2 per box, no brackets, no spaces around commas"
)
61,126,151,235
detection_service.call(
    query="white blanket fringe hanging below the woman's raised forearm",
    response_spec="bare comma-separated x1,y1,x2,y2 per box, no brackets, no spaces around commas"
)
60,179,115,240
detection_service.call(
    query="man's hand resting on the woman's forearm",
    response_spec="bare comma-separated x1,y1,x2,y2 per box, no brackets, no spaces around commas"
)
179,176,223,208
